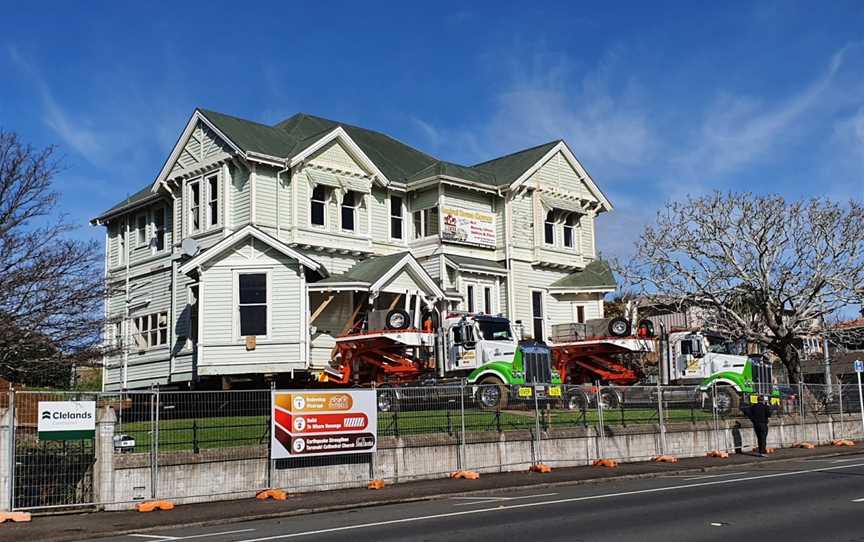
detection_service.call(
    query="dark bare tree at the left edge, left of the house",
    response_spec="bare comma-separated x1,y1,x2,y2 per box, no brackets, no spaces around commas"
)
0,130,104,385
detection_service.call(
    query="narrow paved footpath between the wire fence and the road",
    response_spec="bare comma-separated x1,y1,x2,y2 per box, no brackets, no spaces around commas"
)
0,446,861,542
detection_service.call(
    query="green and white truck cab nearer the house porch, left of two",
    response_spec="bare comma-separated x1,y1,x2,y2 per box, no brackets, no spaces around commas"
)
443,315,561,409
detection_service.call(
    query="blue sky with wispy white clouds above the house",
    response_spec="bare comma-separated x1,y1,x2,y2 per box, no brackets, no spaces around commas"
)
0,0,864,255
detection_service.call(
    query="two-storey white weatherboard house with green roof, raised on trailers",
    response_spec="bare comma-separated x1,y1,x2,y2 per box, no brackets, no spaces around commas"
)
93,109,615,390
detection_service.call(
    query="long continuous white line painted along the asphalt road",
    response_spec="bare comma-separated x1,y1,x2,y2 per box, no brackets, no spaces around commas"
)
236,463,864,542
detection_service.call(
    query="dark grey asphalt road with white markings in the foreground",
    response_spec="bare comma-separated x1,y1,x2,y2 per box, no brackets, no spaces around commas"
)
94,454,864,542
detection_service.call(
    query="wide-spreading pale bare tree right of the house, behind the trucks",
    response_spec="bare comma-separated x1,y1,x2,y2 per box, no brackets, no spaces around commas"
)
617,192,864,382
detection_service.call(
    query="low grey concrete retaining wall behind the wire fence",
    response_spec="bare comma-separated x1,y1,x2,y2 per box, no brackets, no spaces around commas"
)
89,415,864,510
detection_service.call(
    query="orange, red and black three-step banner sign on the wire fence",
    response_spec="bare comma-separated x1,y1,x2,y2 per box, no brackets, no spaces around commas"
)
270,390,378,459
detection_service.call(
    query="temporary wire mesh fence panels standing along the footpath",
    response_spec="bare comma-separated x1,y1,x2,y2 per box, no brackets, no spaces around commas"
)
0,383,864,511
